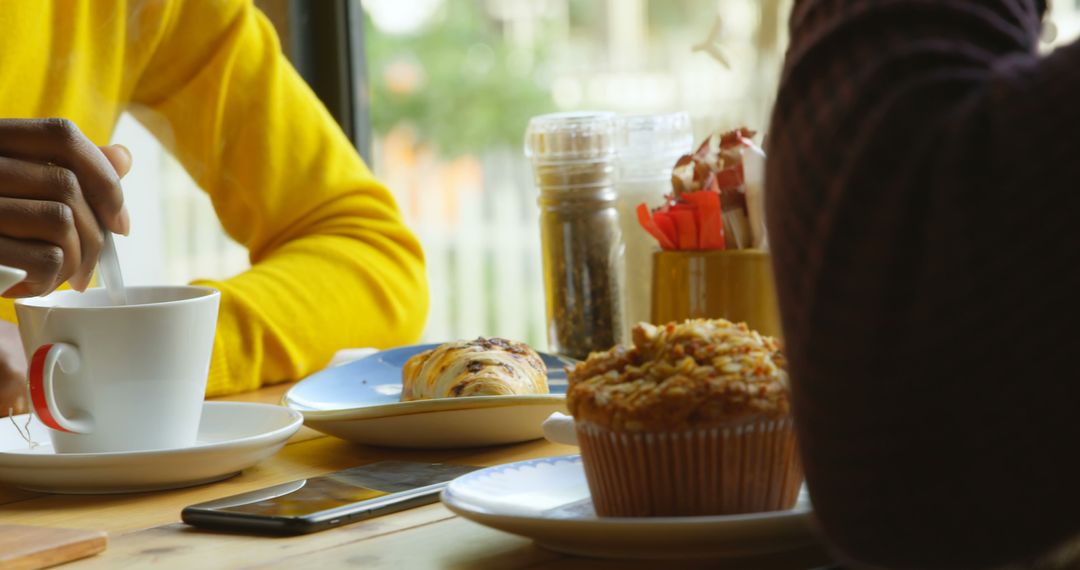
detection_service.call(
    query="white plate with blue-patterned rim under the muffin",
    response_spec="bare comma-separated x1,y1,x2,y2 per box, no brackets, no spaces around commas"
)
443,456,815,558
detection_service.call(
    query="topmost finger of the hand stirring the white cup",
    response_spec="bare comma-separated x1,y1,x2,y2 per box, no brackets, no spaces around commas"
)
0,119,129,235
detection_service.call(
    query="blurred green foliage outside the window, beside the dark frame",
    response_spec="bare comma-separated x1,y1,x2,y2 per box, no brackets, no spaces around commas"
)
365,1,555,157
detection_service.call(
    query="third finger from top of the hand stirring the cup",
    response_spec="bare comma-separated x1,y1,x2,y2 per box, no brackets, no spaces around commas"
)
0,198,82,286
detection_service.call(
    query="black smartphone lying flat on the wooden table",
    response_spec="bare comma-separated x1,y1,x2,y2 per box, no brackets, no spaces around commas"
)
180,461,480,534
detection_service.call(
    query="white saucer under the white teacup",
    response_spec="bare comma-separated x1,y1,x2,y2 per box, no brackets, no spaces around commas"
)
0,402,303,493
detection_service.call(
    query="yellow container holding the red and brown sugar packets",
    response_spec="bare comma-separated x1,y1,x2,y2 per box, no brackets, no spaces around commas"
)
652,249,781,338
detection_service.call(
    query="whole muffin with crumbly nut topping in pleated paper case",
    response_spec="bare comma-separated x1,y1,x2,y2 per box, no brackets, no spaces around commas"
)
567,320,802,516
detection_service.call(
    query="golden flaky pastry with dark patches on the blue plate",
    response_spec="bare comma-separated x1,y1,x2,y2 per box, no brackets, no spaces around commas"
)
402,338,548,402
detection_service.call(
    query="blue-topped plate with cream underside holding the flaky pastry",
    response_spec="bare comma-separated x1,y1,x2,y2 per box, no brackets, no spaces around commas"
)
282,344,575,449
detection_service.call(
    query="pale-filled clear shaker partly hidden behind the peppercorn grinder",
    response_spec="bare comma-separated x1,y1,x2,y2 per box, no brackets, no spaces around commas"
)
616,112,693,342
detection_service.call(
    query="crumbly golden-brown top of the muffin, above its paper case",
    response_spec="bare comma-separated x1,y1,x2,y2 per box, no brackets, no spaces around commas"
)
567,320,791,432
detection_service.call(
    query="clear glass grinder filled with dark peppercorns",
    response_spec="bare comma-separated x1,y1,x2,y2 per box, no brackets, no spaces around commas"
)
525,112,623,358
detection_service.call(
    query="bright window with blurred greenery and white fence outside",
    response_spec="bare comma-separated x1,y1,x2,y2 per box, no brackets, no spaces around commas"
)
116,0,1080,348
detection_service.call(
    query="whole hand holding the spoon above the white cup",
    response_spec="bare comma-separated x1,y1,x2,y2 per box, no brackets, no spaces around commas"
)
0,119,132,297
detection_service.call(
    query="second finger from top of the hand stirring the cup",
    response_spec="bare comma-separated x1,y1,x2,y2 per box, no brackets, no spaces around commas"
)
0,157,104,290
